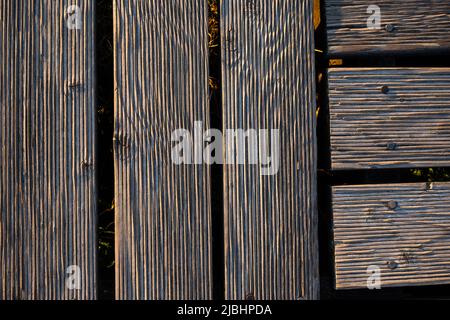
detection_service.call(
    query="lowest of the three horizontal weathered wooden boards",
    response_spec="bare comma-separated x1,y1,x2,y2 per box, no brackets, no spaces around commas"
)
333,183,450,289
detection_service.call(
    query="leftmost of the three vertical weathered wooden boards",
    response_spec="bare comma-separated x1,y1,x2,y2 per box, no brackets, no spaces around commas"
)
0,0,97,300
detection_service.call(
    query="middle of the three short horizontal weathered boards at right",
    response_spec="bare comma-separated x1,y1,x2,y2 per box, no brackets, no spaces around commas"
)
328,68,450,169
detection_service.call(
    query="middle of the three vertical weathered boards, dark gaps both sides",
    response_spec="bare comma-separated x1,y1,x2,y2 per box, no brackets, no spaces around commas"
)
114,0,212,299
